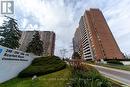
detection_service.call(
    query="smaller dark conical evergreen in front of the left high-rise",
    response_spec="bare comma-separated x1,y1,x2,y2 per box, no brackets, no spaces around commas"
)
26,31,43,55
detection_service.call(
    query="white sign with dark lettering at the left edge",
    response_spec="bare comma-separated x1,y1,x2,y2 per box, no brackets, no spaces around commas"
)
0,46,34,83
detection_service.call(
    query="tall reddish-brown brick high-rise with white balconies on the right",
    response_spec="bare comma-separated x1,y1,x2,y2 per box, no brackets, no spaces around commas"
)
73,9,124,60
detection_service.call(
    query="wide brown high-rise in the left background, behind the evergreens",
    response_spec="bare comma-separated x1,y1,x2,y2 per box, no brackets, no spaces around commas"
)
19,31,55,56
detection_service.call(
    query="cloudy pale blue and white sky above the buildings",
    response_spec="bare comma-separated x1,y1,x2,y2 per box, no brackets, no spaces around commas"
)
0,0,130,57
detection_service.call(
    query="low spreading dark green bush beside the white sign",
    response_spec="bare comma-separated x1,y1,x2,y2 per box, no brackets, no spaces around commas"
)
18,56,66,77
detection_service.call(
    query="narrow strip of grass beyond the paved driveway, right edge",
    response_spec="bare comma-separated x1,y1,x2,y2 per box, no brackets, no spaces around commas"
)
98,64,130,71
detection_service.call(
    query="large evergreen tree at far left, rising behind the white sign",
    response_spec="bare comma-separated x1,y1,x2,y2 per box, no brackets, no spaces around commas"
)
0,16,21,49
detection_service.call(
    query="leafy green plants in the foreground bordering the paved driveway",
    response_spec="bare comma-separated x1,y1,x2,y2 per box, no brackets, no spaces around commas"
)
71,65,111,87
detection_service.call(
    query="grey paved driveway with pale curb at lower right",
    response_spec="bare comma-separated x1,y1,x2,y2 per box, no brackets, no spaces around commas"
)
89,64,130,86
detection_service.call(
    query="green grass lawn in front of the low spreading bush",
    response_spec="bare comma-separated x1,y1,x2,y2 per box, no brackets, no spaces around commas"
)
0,68,71,87
